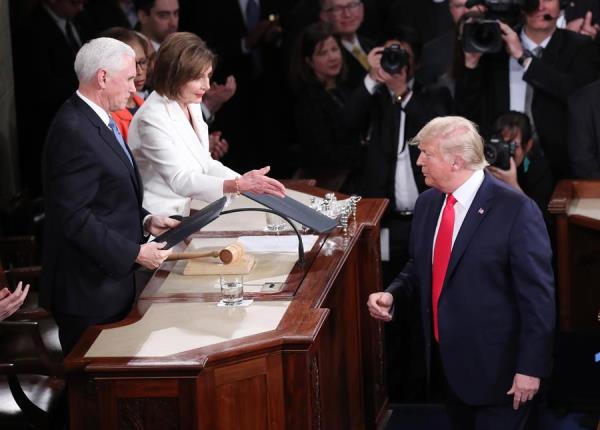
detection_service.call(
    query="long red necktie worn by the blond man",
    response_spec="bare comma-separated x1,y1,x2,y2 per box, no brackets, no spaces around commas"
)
431,194,456,342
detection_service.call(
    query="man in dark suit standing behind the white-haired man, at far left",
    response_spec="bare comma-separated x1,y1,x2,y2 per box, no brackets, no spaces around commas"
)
13,0,88,195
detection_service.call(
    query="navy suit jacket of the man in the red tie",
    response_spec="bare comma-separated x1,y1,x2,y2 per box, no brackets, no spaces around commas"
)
387,174,555,405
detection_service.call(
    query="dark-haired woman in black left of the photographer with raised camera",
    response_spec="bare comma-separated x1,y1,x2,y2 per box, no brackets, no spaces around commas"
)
290,22,363,194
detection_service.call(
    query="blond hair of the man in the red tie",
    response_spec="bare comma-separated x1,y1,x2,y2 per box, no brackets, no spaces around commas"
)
410,116,488,170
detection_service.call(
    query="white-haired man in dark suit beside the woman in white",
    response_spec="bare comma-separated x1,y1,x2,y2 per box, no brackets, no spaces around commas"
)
40,38,177,355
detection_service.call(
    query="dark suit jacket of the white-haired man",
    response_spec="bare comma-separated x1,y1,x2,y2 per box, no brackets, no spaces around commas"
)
40,95,147,318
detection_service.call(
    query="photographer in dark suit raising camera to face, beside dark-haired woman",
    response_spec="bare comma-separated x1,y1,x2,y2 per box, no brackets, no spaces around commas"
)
347,26,452,274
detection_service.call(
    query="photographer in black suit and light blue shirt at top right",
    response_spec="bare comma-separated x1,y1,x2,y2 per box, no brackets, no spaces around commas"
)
456,0,600,180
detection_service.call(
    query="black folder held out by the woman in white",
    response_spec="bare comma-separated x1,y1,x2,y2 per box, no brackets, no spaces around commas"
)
242,192,338,233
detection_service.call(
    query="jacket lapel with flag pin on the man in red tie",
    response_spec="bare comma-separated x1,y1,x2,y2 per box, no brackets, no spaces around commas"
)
445,175,493,282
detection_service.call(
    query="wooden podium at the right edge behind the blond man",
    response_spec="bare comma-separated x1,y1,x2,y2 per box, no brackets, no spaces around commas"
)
548,180,600,331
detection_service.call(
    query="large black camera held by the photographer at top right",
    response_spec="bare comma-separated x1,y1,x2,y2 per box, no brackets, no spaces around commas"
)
461,0,539,54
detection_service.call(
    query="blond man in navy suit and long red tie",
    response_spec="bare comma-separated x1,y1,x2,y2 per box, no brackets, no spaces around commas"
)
367,117,555,430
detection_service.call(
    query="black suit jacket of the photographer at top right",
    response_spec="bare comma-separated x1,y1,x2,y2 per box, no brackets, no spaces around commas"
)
456,29,600,179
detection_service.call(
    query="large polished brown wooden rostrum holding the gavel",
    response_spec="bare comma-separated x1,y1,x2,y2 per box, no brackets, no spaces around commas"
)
66,185,388,430
